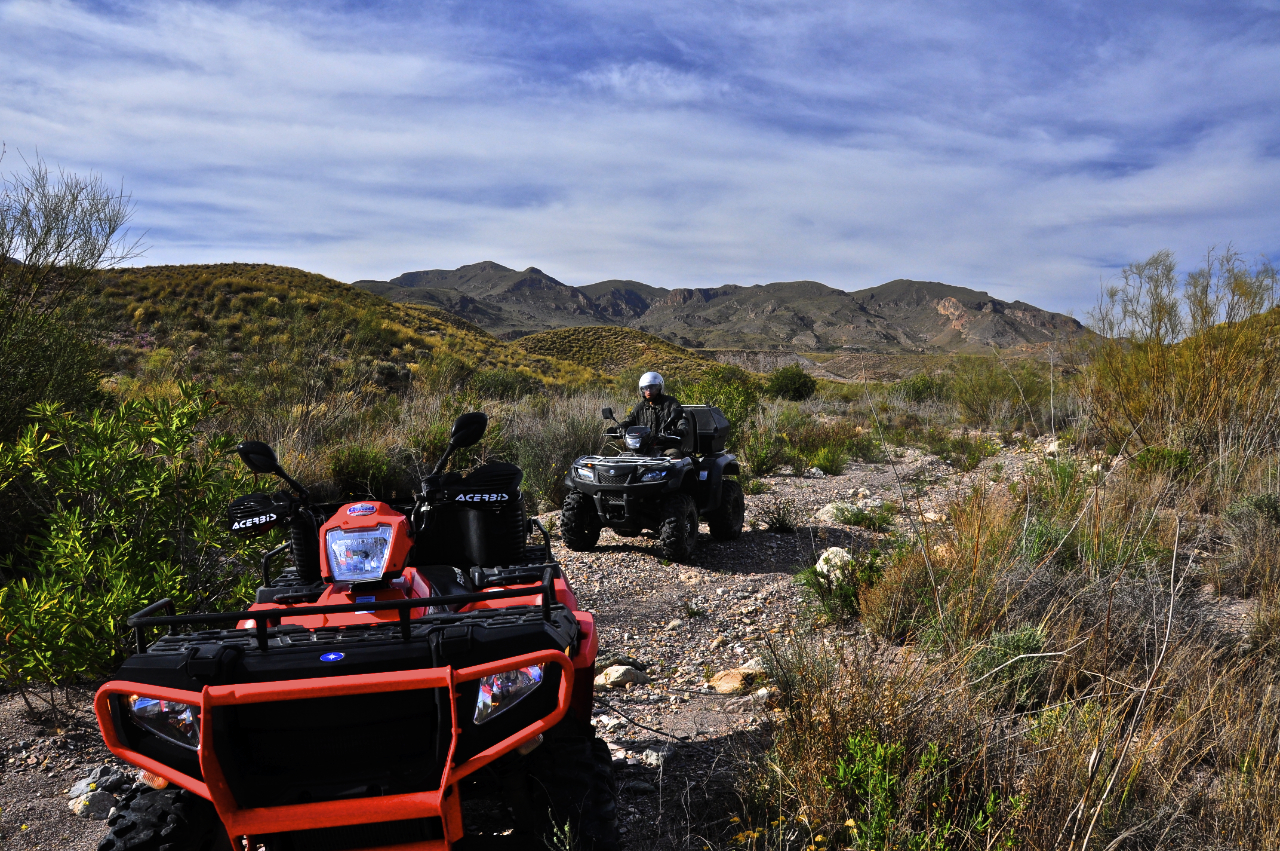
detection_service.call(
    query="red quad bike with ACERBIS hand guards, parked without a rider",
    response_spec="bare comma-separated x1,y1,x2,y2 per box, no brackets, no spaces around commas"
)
95,413,617,851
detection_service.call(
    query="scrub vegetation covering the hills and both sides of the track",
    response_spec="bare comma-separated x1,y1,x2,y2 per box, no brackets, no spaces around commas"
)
0,157,1280,851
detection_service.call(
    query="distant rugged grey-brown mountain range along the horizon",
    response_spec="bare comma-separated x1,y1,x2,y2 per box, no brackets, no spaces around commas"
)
352,261,1091,353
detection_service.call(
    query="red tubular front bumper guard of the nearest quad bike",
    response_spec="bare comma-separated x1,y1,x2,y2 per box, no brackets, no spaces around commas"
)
93,647,576,851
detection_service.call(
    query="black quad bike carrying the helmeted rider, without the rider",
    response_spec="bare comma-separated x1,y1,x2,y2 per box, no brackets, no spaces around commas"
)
561,404,746,562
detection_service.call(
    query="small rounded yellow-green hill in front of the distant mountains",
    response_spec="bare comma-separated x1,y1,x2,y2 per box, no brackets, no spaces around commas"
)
515,325,714,378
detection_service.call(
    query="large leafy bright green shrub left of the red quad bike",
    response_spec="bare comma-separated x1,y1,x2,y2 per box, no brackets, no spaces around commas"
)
0,385,259,687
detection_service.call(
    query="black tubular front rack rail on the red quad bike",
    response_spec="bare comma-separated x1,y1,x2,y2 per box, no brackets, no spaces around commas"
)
127,564,559,653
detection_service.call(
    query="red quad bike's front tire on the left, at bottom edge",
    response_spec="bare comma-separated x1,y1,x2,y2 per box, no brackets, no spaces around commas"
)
97,783,232,851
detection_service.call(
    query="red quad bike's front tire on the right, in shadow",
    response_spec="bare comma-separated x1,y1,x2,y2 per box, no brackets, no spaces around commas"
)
512,718,618,851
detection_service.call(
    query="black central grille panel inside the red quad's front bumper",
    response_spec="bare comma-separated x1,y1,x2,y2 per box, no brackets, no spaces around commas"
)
210,688,448,807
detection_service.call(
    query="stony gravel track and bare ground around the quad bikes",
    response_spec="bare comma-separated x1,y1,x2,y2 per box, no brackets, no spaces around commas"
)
0,435,1187,850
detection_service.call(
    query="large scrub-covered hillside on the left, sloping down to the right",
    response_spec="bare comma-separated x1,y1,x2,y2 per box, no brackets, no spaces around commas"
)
92,264,599,383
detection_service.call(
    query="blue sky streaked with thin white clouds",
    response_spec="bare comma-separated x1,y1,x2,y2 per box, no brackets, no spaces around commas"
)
0,0,1280,317
